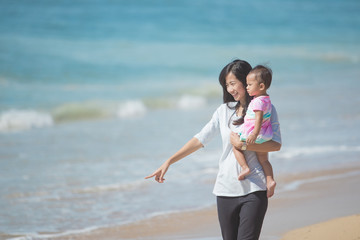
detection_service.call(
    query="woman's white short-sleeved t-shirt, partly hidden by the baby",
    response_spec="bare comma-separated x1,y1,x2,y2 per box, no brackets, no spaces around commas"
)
194,102,281,197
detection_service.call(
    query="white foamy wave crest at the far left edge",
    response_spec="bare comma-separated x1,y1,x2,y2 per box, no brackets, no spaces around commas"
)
0,109,54,132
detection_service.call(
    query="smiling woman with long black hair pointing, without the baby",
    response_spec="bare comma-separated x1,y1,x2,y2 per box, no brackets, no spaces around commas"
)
146,60,281,240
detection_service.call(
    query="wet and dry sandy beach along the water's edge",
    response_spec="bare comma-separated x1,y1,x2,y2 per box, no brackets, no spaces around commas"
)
3,163,360,240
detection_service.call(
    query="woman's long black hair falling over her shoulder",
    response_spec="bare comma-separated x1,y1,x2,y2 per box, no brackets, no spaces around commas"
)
219,59,252,125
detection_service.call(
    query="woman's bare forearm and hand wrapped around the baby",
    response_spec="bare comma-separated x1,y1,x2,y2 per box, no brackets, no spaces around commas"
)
230,132,281,152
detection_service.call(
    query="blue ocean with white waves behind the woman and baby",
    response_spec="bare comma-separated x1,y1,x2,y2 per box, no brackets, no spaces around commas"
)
0,0,360,239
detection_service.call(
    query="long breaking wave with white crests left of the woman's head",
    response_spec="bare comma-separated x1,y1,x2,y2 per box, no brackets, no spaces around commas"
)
0,94,212,132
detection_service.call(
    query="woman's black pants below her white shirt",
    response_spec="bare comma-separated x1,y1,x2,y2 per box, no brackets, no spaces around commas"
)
217,191,268,240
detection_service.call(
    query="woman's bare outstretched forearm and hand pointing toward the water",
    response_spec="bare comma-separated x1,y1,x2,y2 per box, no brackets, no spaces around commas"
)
145,137,203,183
